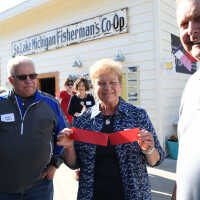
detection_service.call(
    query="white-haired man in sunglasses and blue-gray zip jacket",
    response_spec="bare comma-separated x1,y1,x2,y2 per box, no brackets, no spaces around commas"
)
0,56,67,200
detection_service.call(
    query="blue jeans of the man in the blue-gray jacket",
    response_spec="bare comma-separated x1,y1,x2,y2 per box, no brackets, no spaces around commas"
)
0,179,53,200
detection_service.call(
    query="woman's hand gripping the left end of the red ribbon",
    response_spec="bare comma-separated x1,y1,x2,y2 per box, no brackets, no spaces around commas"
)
57,128,74,148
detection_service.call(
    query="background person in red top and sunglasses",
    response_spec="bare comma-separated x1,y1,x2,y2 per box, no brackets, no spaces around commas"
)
56,78,76,125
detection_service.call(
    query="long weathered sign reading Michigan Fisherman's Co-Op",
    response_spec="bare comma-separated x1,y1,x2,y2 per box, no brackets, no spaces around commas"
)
11,8,128,56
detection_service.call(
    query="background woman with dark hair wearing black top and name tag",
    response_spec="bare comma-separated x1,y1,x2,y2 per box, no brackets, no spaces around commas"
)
68,77,95,117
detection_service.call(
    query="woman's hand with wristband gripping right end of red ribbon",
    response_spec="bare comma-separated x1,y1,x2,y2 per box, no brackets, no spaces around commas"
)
138,129,155,152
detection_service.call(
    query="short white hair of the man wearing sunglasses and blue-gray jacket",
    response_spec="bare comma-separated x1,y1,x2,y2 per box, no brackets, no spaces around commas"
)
7,56,35,77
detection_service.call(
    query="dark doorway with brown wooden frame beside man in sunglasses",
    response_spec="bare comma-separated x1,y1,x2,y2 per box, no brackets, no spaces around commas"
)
38,72,59,96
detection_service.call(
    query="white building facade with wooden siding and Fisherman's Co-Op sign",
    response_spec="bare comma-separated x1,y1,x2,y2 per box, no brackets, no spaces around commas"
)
0,0,194,150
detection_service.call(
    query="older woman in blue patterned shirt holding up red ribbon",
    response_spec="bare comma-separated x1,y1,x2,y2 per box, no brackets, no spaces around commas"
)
58,59,165,200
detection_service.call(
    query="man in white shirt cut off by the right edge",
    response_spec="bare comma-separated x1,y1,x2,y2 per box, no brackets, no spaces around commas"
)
176,0,200,200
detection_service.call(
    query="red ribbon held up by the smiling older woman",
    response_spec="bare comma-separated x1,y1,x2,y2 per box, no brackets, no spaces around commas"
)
70,128,140,146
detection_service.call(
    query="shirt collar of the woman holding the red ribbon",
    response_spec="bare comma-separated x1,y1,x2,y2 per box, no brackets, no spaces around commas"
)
91,97,128,119
